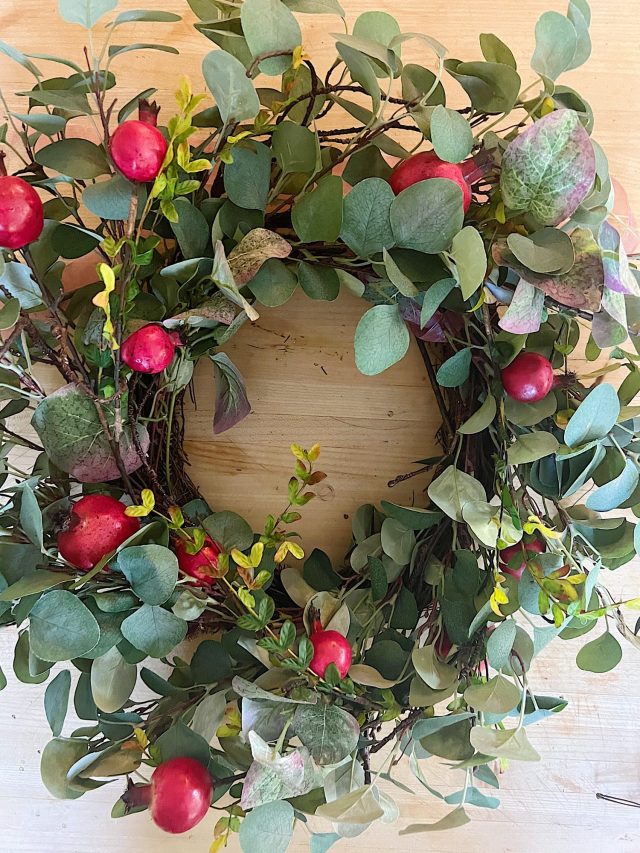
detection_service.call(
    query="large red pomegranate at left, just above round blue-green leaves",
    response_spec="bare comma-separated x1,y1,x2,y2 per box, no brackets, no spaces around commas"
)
58,495,140,571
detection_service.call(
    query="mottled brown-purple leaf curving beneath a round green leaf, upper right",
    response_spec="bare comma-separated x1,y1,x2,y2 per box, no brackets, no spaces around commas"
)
492,228,604,311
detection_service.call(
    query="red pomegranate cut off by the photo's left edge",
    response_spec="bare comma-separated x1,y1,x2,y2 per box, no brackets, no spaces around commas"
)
0,151,44,252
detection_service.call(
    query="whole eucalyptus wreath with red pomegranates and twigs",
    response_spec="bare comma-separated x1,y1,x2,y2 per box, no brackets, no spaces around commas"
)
0,0,640,853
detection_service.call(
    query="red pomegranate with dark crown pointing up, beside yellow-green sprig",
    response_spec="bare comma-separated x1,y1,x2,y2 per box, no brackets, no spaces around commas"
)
109,100,168,184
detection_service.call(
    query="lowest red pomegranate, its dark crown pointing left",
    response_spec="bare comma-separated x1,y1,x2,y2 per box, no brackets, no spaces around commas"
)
122,758,214,835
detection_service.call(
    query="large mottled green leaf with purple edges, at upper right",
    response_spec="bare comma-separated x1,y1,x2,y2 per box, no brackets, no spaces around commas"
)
500,110,596,225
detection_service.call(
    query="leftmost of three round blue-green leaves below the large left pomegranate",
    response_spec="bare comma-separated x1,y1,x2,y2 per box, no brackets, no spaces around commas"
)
29,589,100,661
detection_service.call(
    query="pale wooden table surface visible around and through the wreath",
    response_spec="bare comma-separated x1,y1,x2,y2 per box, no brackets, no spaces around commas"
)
0,0,640,853
